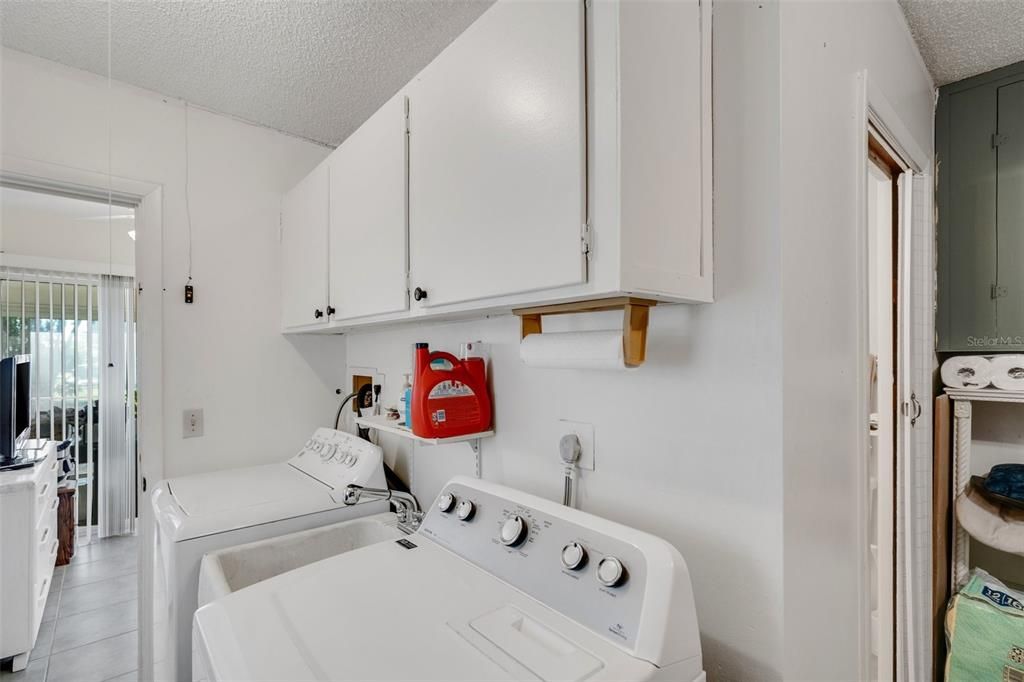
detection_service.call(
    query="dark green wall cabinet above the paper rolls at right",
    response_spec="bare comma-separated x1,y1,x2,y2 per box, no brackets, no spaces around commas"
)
935,62,1024,351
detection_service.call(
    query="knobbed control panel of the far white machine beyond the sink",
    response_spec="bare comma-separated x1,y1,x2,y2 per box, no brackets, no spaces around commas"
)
289,428,383,492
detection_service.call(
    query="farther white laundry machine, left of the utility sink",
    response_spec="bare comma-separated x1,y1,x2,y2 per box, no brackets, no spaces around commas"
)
149,428,388,681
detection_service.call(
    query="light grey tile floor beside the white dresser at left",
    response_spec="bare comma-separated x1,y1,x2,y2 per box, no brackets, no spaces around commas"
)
0,536,138,682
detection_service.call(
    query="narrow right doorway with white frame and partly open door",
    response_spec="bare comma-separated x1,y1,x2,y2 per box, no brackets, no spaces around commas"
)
857,72,935,682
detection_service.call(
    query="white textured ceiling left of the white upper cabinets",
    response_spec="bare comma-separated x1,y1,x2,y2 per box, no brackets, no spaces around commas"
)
0,0,490,145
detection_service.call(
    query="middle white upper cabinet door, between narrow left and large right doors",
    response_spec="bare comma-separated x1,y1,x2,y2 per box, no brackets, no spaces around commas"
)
330,93,409,319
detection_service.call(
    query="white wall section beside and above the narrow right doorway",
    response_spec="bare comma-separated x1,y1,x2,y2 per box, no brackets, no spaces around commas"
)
779,0,933,680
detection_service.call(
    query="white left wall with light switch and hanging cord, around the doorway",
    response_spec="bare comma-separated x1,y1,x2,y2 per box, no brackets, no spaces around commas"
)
0,49,344,475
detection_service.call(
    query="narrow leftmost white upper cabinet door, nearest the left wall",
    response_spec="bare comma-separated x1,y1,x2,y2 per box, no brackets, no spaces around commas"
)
281,164,329,329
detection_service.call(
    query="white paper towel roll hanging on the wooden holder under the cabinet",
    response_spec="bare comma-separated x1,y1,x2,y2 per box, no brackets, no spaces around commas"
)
519,330,629,370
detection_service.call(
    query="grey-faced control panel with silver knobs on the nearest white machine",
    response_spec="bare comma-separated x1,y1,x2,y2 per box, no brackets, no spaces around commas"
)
420,478,692,648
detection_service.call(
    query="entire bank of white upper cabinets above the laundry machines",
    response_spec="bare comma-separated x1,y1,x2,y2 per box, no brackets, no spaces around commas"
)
284,0,714,332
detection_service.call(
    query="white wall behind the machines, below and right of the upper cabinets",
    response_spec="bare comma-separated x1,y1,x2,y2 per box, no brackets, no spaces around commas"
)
347,3,782,680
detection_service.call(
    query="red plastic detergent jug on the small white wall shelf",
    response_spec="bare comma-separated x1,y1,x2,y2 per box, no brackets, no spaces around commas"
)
413,343,490,438
